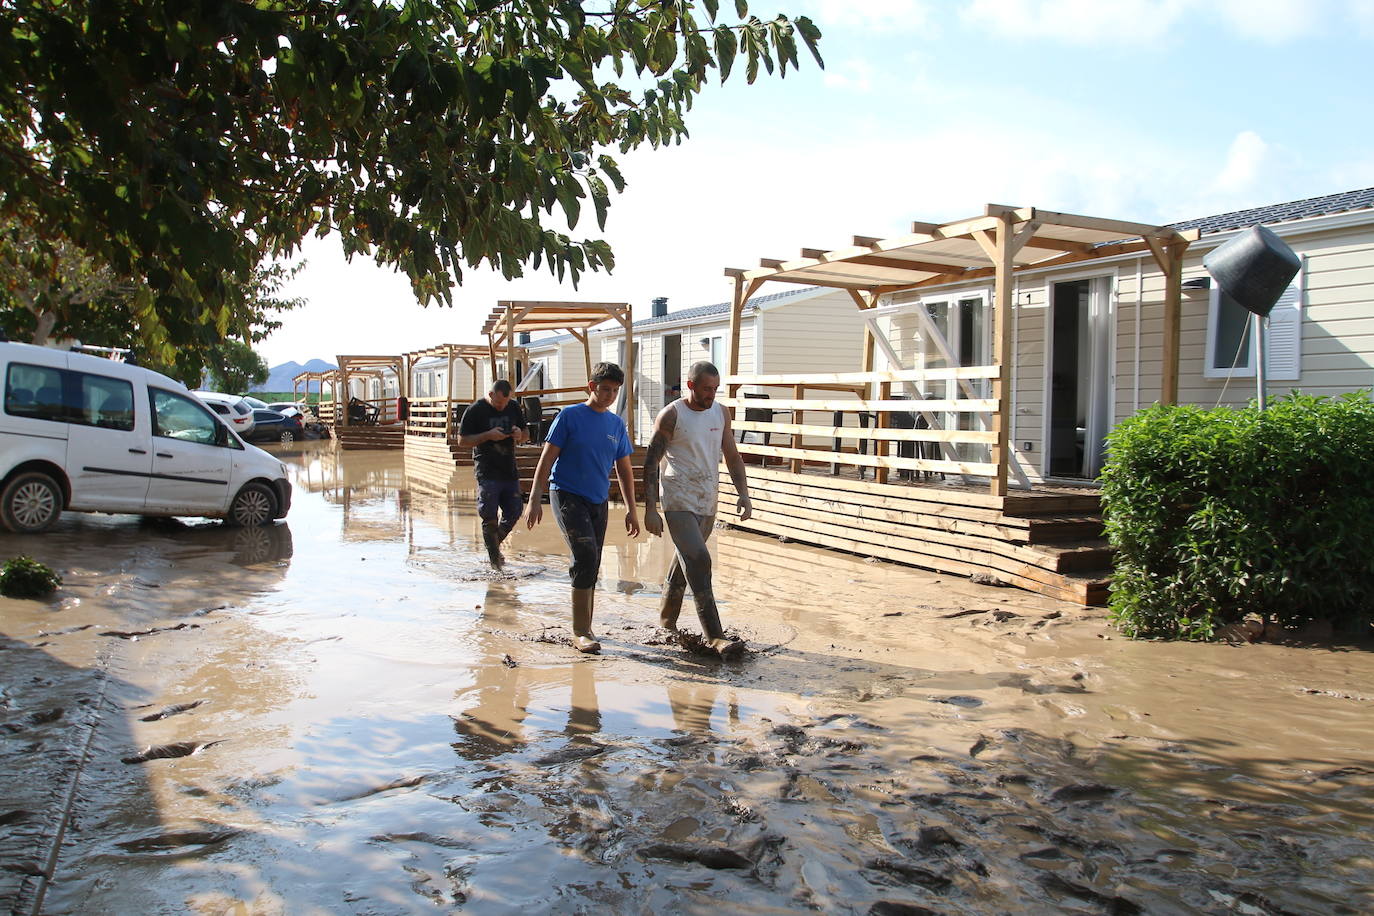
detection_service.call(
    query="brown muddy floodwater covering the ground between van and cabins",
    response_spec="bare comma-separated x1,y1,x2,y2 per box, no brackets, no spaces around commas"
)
0,444,1374,913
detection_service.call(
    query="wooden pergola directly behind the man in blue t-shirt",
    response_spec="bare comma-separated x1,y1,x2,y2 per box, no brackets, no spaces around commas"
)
482,299,635,442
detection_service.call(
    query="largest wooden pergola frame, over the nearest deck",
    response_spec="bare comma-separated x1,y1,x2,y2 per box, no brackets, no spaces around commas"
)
725,203,1198,496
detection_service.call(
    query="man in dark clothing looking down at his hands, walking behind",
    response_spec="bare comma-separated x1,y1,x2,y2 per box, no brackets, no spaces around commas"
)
458,379,529,569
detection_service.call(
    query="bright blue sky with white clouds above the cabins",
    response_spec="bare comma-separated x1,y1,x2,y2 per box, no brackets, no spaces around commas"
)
257,0,1374,367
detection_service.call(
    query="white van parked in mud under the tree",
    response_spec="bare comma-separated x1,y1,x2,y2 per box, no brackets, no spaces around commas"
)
0,342,291,533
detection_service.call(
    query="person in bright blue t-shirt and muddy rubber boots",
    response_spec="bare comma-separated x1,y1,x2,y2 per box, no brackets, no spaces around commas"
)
525,363,639,652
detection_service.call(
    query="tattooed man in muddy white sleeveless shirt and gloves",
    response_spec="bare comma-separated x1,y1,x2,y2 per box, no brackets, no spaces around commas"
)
644,363,753,658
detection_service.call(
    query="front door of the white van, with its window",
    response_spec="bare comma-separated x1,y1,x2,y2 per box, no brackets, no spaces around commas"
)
147,389,232,515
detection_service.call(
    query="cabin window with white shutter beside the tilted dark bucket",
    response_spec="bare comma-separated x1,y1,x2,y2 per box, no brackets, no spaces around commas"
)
1202,273,1303,379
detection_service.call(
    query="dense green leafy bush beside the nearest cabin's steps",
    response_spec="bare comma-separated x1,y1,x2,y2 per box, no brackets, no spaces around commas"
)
1102,391,1374,640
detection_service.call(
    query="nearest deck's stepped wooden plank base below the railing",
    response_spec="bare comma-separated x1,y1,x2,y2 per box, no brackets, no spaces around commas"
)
720,466,1112,604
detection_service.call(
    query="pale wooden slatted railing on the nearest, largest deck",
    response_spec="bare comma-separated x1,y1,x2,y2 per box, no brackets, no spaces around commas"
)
719,365,1000,482
